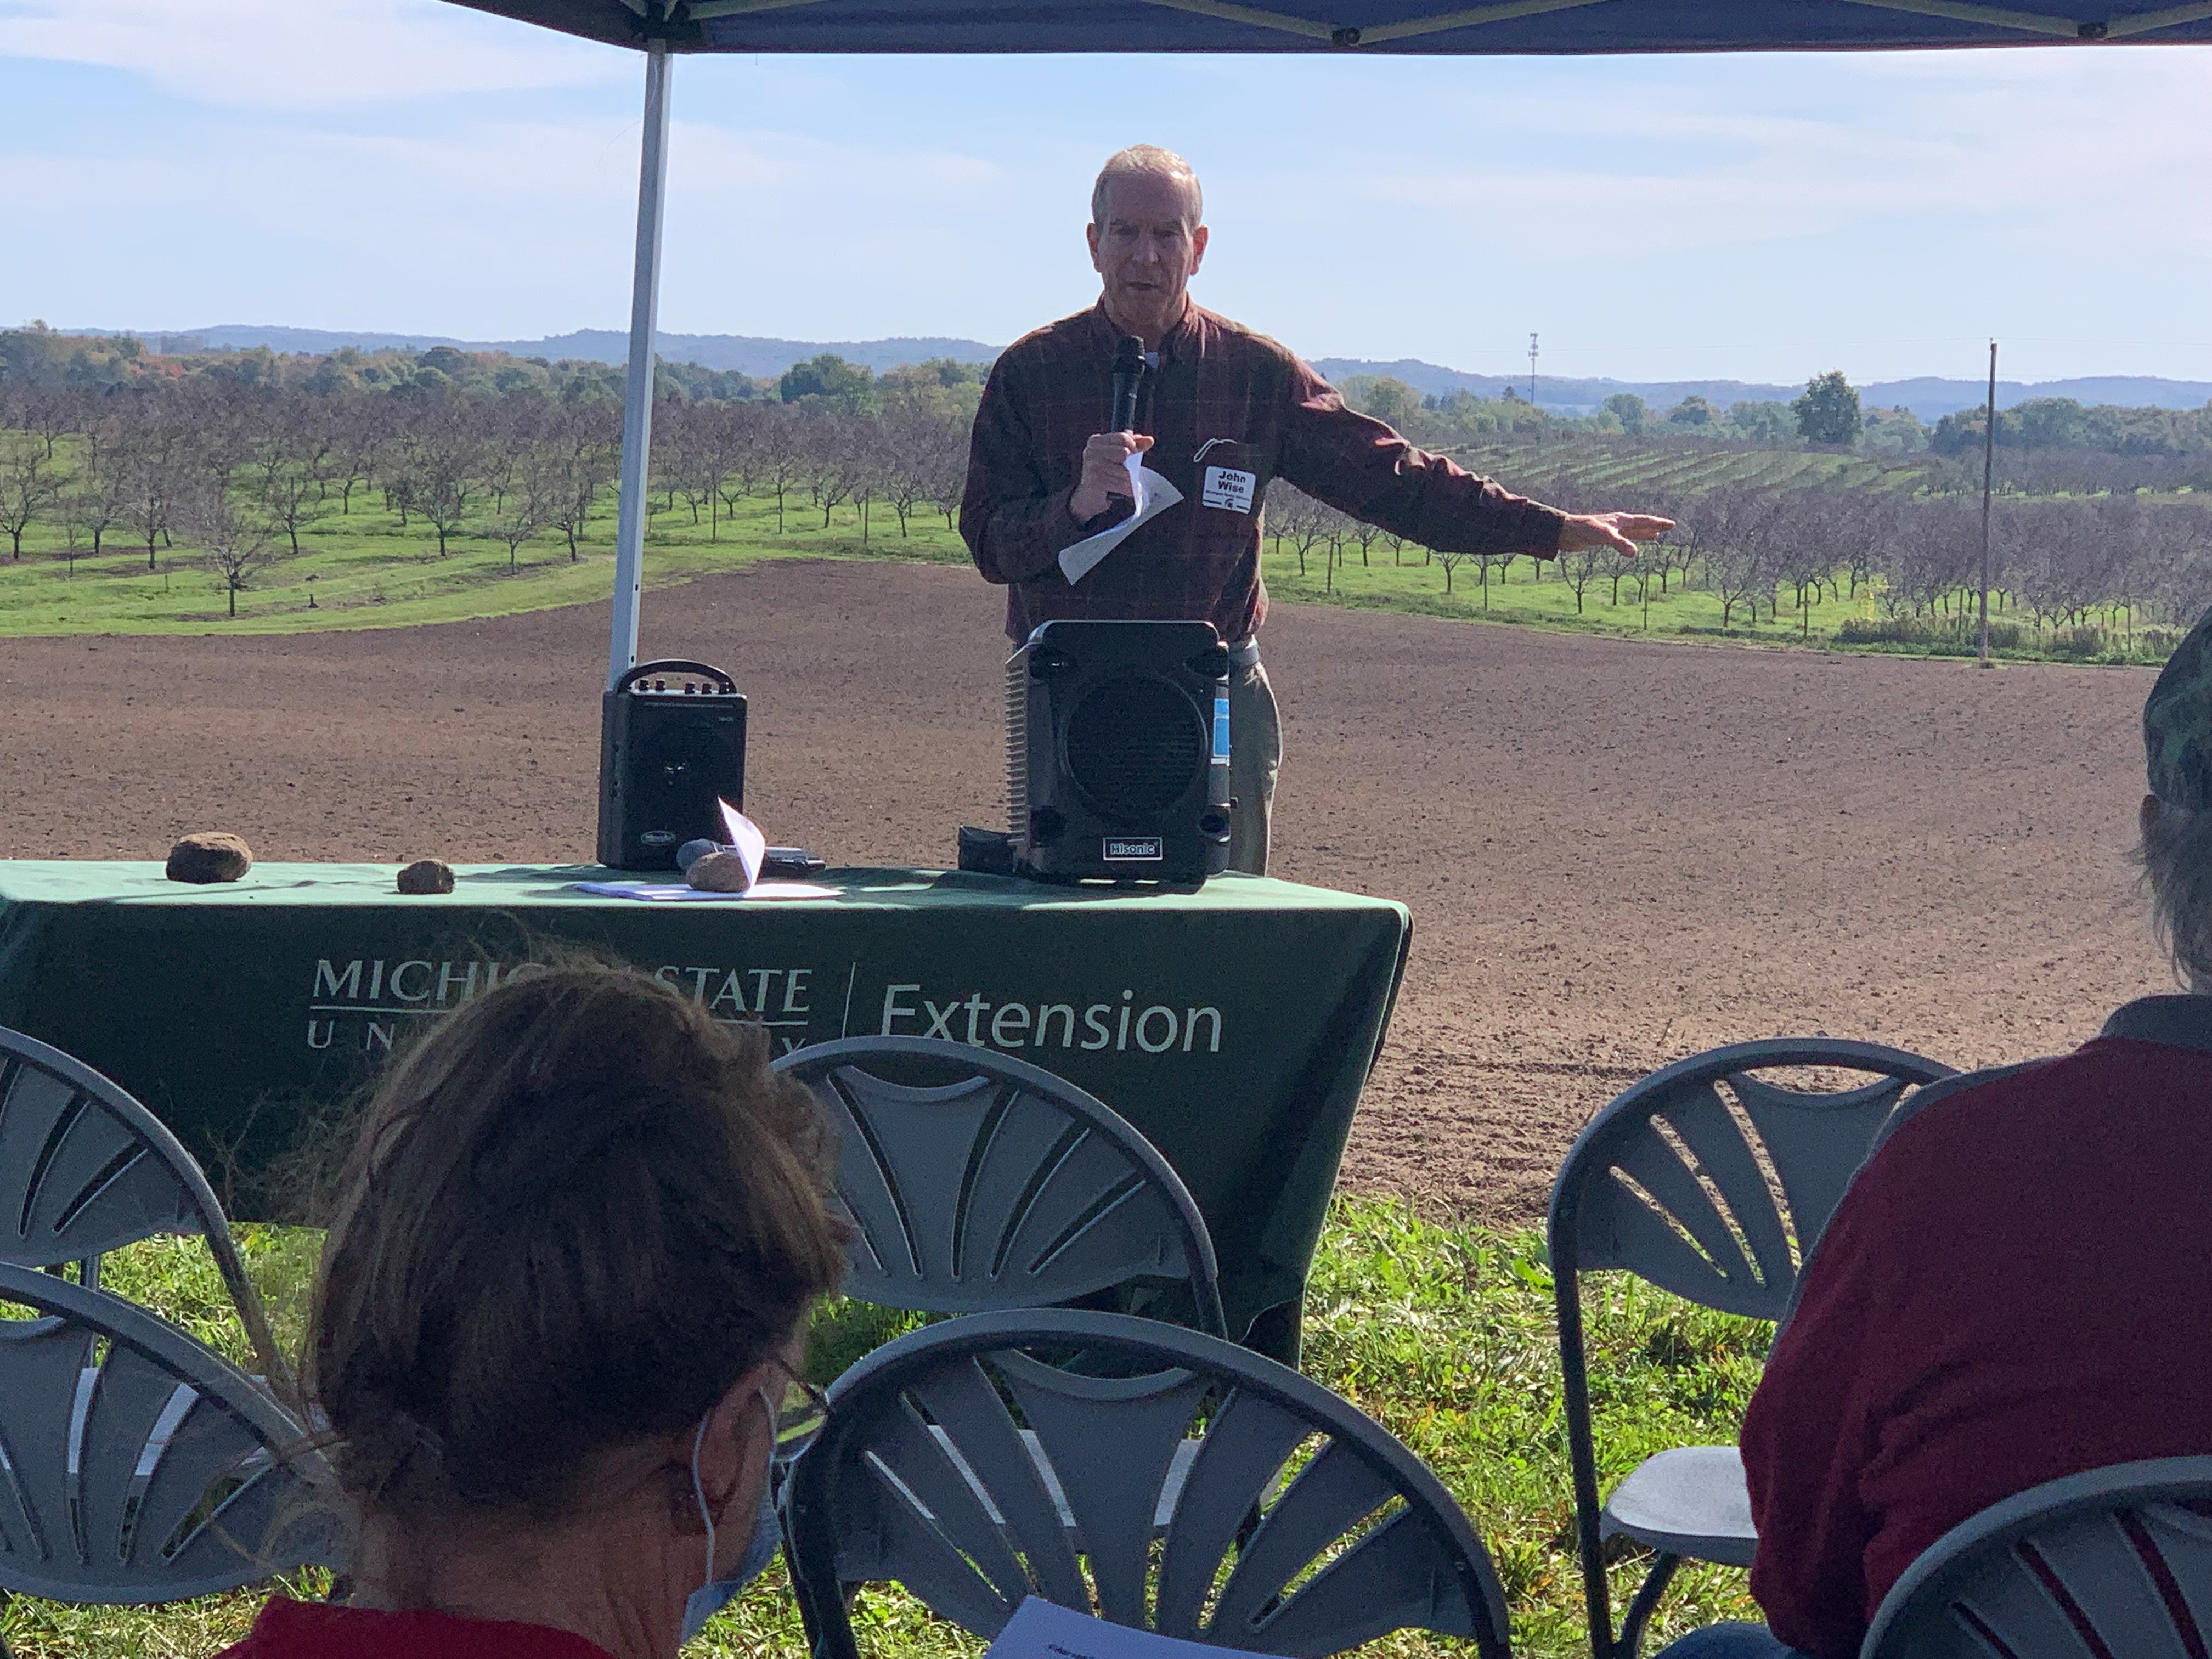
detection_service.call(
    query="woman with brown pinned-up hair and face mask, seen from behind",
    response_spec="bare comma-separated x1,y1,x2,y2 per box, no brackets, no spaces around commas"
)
225,967,845,1659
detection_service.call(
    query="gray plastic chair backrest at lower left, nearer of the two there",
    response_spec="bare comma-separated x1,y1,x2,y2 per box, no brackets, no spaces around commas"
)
0,1265,330,1604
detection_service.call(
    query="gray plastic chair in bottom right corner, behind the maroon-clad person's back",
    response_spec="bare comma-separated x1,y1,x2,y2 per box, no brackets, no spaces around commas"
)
1860,1458,2212,1659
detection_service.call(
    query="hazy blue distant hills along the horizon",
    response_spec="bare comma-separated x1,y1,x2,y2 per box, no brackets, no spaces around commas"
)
71,323,2212,420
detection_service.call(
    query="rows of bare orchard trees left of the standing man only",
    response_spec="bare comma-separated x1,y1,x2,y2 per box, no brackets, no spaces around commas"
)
0,378,967,615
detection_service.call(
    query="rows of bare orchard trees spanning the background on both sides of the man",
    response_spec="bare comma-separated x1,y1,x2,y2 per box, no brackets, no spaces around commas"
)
13,354,2212,635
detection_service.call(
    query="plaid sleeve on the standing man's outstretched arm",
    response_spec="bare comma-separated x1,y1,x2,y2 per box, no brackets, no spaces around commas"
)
1281,363,1566,557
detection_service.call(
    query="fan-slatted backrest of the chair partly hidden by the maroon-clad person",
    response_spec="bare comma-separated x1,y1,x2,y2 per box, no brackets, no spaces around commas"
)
1550,1037,1953,1318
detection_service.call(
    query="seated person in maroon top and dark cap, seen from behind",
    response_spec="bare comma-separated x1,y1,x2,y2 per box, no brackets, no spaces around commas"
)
1663,615,2212,1659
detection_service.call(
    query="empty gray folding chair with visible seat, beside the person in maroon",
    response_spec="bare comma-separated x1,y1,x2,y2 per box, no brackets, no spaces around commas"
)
1548,1037,1951,1659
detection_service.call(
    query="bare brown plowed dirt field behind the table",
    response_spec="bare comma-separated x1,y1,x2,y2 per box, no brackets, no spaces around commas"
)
0,562,2170,1221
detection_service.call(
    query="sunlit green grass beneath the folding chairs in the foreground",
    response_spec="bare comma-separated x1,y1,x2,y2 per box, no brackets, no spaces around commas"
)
0,1199,1772,1659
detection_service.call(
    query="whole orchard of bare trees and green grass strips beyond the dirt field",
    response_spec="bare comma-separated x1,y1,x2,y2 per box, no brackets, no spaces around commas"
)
0,334,2212,659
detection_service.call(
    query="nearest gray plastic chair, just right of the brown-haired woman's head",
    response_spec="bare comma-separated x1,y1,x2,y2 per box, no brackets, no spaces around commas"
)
783,1310,1506,1659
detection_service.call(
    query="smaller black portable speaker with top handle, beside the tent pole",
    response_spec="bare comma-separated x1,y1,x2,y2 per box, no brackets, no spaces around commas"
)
600,662,746,870
